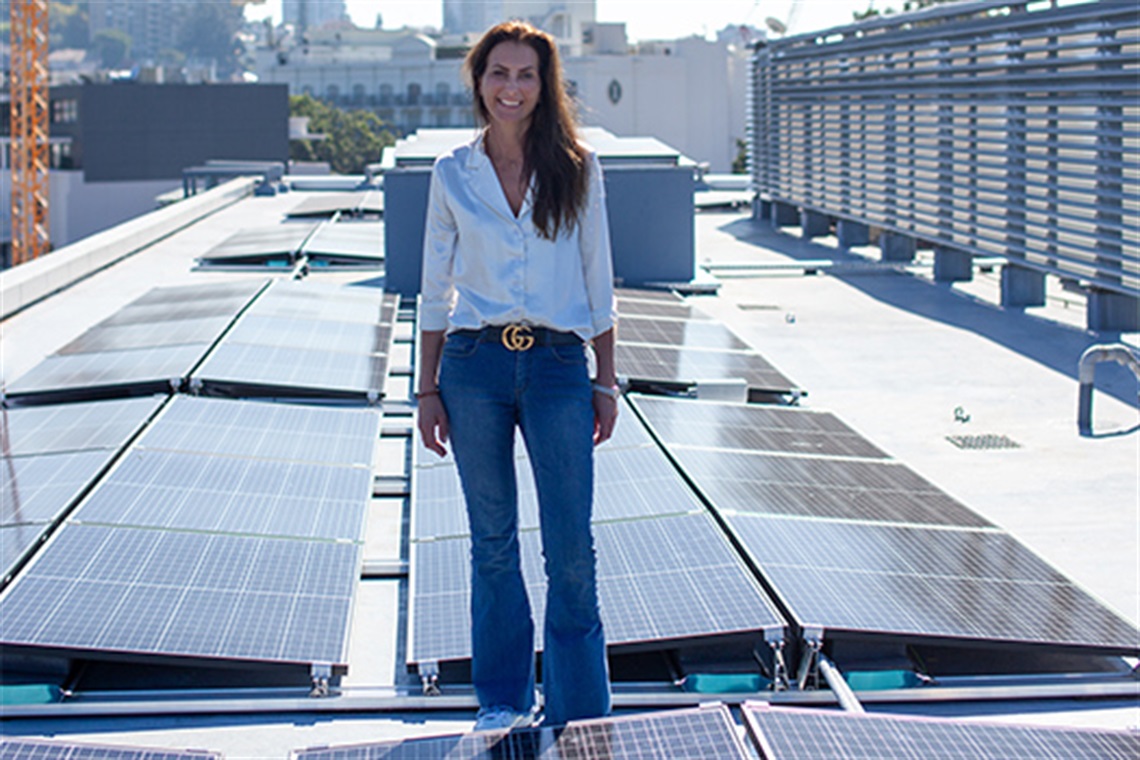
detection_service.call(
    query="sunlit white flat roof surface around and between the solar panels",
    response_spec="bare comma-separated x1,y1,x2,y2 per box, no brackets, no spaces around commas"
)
0,200,1140,758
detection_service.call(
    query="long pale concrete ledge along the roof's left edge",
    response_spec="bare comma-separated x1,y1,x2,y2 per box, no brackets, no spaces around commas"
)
0,177,258,319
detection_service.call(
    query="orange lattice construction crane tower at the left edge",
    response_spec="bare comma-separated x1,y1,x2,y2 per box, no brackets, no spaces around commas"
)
9,0,51,265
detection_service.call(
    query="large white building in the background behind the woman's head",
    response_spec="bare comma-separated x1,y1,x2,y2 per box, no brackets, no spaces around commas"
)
255,23,748,172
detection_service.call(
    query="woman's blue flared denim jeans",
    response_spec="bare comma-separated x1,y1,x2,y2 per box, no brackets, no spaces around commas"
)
439,334,610,724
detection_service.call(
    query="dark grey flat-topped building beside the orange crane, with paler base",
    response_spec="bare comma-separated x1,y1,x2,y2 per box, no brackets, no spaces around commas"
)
0,82,288,255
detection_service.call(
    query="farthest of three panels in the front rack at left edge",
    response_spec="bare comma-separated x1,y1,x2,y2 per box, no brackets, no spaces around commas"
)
0,397,165,457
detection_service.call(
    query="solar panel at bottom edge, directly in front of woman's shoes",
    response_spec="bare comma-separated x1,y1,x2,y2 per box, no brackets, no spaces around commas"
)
292,704,749,760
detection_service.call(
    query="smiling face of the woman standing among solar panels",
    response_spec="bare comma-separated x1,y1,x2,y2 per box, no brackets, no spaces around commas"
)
479,40,543,132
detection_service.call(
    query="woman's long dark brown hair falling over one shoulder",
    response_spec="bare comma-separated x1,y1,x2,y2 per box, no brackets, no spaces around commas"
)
463,21,587,240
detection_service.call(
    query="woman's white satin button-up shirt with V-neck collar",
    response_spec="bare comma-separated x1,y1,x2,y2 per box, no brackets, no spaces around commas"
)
420,134,617,341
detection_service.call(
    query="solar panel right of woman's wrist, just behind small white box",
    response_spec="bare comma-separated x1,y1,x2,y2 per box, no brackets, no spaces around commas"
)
614,341,796,393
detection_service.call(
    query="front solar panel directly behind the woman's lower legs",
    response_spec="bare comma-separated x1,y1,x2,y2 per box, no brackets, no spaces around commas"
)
408,513,784,663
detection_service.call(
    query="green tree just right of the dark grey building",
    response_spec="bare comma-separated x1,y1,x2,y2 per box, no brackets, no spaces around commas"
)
288,95,396,174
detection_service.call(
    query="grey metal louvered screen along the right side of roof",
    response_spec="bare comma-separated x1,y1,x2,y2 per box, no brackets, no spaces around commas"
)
749,1,1140,303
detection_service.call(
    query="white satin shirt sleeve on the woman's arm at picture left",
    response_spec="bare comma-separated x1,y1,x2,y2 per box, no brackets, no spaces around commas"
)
420,161,457,330
